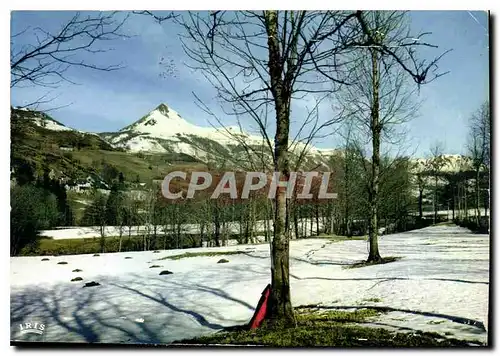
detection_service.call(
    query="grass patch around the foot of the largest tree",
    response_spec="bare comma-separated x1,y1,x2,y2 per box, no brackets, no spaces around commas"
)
176,308,478,347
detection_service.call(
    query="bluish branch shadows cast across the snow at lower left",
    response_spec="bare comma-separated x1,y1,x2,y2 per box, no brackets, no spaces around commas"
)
11,272,258,344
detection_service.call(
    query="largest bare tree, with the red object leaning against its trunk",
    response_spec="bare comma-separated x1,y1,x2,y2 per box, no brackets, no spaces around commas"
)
179,11,370,322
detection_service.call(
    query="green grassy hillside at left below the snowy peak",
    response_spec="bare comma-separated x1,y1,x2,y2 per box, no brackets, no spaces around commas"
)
11,109,201,185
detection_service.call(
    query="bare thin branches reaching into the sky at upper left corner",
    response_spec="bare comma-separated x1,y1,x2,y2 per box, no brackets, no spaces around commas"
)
10,12,127,91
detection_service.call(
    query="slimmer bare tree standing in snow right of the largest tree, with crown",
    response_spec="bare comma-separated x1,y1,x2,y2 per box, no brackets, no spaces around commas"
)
340,11,442,262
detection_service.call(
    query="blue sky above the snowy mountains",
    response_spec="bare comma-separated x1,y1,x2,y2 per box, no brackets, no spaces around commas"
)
11,11,489,156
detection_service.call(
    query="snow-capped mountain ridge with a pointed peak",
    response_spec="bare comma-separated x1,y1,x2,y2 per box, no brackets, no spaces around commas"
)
13,103,469,171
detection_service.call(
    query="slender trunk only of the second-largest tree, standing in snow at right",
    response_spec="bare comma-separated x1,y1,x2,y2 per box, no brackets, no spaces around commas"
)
368,49,382,262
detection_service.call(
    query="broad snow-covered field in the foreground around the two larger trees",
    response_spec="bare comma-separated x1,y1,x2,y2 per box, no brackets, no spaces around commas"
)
10,226,489,343
